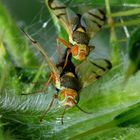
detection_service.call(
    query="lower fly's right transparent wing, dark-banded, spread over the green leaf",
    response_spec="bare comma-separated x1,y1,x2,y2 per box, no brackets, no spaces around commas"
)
76,58,112,87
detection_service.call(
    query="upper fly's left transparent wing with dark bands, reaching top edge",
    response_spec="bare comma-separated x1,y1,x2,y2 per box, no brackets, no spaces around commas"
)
48,0,79,35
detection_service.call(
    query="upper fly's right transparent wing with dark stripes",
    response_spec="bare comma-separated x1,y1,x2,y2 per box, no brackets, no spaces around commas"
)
81,9,105,37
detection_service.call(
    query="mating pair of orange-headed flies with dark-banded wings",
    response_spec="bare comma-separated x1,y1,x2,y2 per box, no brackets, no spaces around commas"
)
23,0,112,124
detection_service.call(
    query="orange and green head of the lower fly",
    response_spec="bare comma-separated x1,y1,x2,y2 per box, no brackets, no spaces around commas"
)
58,88,78,107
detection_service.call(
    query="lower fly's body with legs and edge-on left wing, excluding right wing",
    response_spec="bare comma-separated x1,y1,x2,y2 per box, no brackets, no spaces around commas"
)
22,30,90,124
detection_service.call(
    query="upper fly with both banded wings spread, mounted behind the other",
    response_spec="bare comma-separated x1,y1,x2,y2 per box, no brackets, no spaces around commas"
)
47,0,105,67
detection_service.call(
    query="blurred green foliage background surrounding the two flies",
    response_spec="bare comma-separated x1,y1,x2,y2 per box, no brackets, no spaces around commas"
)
0,0,140,140
